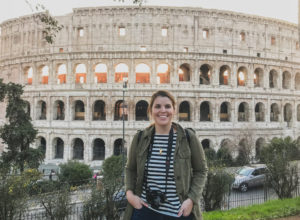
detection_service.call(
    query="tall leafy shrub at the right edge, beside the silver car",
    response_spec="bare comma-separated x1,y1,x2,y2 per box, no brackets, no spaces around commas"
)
262,137,299,199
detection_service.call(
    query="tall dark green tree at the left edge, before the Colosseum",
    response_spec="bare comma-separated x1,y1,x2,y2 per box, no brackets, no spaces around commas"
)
0,80,44,172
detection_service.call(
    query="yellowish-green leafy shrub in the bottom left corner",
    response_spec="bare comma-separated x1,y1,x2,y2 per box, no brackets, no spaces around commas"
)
0,166,41,220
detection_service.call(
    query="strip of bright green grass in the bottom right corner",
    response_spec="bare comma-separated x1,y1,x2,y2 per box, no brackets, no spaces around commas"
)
203,197,300,220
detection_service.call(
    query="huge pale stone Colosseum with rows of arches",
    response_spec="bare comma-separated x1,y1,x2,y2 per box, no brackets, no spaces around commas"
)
0,6,300,166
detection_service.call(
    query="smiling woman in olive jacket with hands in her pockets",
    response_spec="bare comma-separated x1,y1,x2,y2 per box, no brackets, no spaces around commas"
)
124,90,207,220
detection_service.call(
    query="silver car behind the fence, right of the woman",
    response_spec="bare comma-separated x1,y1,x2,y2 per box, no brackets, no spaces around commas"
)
232,165,266,192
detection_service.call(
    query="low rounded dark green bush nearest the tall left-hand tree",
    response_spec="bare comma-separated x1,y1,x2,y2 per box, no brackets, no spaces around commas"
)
58,161,93,186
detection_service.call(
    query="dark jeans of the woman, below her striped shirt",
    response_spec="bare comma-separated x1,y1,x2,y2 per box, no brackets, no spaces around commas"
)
131,206,193,220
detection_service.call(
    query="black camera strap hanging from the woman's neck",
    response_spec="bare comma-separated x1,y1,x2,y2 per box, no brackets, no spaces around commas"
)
144,127,174,193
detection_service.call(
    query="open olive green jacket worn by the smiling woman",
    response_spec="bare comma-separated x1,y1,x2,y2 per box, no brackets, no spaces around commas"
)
124,123,207,220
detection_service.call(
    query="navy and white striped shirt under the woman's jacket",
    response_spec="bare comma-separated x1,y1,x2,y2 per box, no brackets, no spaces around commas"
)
141,133,181,217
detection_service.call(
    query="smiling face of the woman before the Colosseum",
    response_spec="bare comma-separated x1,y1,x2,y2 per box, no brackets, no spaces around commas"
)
151,96,175,127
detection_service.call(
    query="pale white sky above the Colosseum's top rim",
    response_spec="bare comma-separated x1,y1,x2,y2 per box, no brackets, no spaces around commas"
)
0,0,298,23
